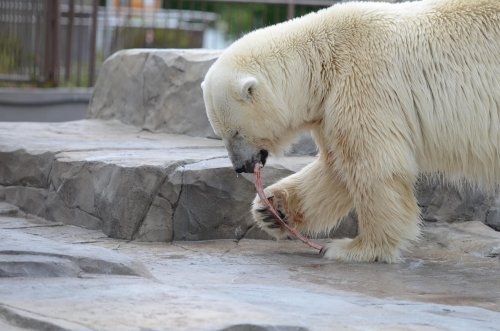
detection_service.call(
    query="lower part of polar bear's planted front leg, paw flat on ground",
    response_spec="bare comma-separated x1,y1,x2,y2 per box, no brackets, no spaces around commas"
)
322,176,420,263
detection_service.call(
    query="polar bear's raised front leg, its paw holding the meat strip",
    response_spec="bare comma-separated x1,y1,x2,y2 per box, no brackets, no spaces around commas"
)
252,158,352,239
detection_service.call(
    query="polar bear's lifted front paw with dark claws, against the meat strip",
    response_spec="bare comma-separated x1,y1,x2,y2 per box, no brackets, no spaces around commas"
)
252,192,289,239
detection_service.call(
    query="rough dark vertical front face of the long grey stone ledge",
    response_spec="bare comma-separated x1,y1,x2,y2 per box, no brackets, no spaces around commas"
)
0,150,334,242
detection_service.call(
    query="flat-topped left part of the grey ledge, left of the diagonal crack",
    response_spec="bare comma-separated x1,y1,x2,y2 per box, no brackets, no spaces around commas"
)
0,120,218,240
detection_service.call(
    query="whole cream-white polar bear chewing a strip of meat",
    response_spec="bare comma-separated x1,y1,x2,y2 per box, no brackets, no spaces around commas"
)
202,0,500,263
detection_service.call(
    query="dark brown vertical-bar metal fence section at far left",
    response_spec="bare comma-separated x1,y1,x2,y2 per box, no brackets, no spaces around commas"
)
0,0,99,86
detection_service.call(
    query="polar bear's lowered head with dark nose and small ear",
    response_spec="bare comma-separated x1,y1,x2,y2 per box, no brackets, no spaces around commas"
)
202,57,291,173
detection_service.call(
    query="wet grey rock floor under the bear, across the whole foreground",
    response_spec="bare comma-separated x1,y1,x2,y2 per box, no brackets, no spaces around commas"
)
0,214,500,331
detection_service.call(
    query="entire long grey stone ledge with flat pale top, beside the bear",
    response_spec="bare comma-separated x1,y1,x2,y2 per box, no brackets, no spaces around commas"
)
0,120,332,241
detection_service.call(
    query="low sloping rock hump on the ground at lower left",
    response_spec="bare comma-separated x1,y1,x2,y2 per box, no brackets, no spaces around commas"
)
0,217,149,277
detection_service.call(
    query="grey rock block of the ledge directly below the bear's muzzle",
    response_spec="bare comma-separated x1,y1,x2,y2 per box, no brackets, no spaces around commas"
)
165,158,298,240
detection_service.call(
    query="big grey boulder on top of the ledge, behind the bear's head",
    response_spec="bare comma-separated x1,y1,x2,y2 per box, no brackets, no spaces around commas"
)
88,49,221,137
